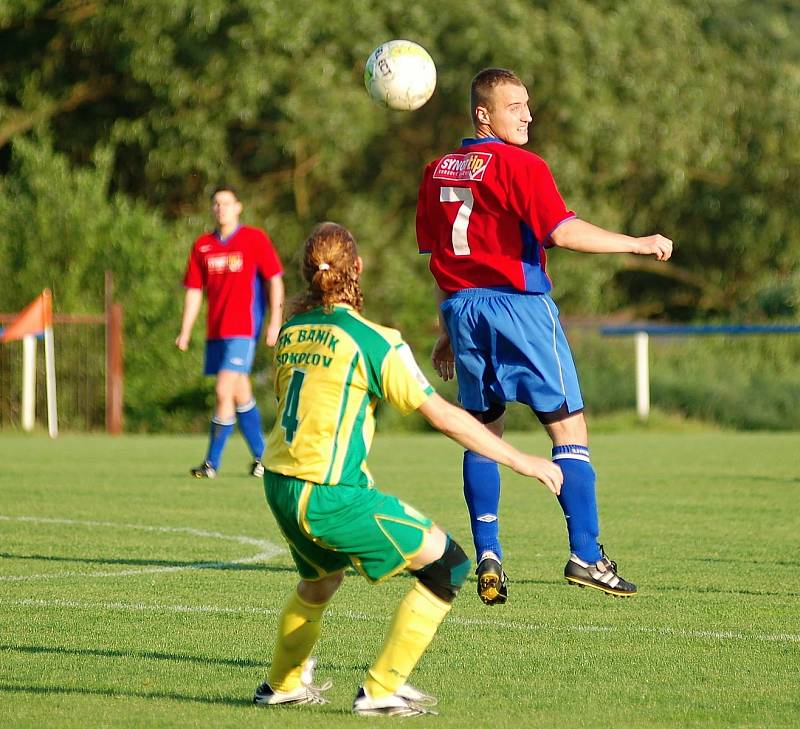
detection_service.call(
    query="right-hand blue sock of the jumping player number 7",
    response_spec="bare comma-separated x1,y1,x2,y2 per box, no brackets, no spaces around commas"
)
553,445,602,562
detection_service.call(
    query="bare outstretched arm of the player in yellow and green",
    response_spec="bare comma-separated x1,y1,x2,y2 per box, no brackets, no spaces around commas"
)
419,394,564,496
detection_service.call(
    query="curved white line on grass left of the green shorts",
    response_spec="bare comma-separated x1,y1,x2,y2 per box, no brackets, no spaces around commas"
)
0,514,286,582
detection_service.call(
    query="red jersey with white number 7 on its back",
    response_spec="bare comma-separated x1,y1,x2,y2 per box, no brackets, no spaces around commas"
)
417,137,575,293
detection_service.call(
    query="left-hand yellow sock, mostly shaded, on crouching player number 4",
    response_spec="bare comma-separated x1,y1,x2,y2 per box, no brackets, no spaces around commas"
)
267,590,328,691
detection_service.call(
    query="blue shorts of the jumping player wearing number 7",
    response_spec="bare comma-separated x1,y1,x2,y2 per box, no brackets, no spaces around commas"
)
441,288,583,413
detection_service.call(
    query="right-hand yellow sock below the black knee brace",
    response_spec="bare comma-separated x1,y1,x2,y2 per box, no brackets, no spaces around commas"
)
364,582,451,699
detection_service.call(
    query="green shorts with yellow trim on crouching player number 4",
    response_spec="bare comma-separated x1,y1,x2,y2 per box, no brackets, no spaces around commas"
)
264,471,432,582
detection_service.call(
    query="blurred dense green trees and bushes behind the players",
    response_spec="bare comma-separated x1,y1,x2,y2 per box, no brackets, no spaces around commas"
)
0,0,800,429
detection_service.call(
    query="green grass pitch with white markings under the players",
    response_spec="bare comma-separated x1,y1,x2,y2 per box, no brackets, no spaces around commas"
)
0,431,800,729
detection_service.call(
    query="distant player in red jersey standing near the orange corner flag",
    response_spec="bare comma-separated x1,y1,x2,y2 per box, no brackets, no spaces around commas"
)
175,187,284,478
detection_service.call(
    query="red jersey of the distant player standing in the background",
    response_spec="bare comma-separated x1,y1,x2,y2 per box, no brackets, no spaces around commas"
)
183,225,283,339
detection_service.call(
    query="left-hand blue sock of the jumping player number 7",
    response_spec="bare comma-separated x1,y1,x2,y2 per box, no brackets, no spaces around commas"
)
464,451,503,559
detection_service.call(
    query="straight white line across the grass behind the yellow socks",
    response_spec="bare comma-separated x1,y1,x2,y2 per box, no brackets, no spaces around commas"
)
0,598,800,643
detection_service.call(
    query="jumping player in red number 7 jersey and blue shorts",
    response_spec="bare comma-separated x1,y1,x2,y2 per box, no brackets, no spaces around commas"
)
417,68,672,605
